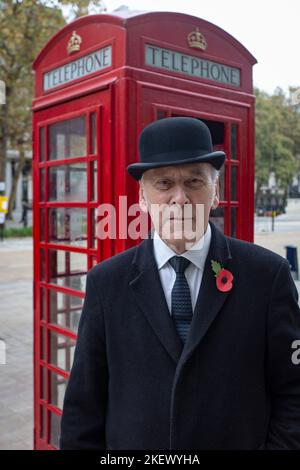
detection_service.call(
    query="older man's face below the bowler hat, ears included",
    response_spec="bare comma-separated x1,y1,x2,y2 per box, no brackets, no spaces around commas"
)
139,163,219,253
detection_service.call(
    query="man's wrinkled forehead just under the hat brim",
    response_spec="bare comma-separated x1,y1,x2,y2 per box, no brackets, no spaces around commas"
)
144,163,211,181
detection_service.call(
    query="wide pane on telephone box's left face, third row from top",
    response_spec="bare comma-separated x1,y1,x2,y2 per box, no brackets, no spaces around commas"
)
49,208,87,247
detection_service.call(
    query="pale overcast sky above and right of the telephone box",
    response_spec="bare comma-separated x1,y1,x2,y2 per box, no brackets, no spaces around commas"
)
105,0,300,93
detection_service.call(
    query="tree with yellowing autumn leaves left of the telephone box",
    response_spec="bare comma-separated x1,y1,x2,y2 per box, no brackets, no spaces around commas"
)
0,0,105,216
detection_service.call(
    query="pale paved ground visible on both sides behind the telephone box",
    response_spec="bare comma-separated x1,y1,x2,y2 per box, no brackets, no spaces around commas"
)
0,200,300,450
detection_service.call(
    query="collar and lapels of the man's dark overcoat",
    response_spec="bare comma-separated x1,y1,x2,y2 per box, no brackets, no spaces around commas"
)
129,222,232,370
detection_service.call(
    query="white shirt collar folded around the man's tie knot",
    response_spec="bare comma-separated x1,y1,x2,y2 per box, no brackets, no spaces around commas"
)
153,223,211,271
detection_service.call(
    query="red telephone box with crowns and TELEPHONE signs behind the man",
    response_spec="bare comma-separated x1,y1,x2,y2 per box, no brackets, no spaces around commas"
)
33,12,256,449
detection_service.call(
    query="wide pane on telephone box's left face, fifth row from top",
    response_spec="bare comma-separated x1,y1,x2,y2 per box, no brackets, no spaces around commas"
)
50,291,83,333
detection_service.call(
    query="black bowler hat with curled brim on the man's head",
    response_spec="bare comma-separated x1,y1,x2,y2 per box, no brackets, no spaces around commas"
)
127,117,225,180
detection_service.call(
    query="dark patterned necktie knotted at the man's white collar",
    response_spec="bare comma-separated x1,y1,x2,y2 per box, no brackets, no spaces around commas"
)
169,256,193,344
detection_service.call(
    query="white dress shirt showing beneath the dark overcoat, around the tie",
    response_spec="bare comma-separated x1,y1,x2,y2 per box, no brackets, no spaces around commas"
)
153,223,211,314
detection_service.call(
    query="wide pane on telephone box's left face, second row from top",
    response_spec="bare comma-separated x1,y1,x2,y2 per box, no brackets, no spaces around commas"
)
49,163,87,202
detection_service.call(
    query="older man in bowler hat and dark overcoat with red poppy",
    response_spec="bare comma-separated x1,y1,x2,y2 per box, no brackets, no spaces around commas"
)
60,117,300,450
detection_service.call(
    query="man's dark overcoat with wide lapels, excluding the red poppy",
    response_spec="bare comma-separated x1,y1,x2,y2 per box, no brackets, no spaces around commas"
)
60,222,300,450
